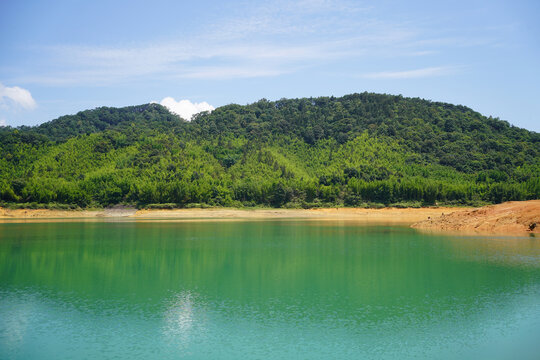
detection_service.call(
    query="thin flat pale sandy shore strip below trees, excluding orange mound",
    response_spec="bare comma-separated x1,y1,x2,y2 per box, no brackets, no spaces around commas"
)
0,207,463,225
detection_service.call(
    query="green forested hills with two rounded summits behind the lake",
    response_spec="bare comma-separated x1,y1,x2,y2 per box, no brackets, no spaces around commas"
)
0,93,540,207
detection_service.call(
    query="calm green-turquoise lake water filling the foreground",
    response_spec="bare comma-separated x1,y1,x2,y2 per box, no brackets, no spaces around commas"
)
0,221,540,360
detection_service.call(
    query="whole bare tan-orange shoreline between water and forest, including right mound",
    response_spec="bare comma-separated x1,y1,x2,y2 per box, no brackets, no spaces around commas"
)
0,200,540,234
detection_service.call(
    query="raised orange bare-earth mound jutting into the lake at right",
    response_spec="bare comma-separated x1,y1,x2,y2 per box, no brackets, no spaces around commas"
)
412,200,540,234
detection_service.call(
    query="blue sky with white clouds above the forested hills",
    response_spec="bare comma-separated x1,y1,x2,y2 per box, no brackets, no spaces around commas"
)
0,0,540,132
